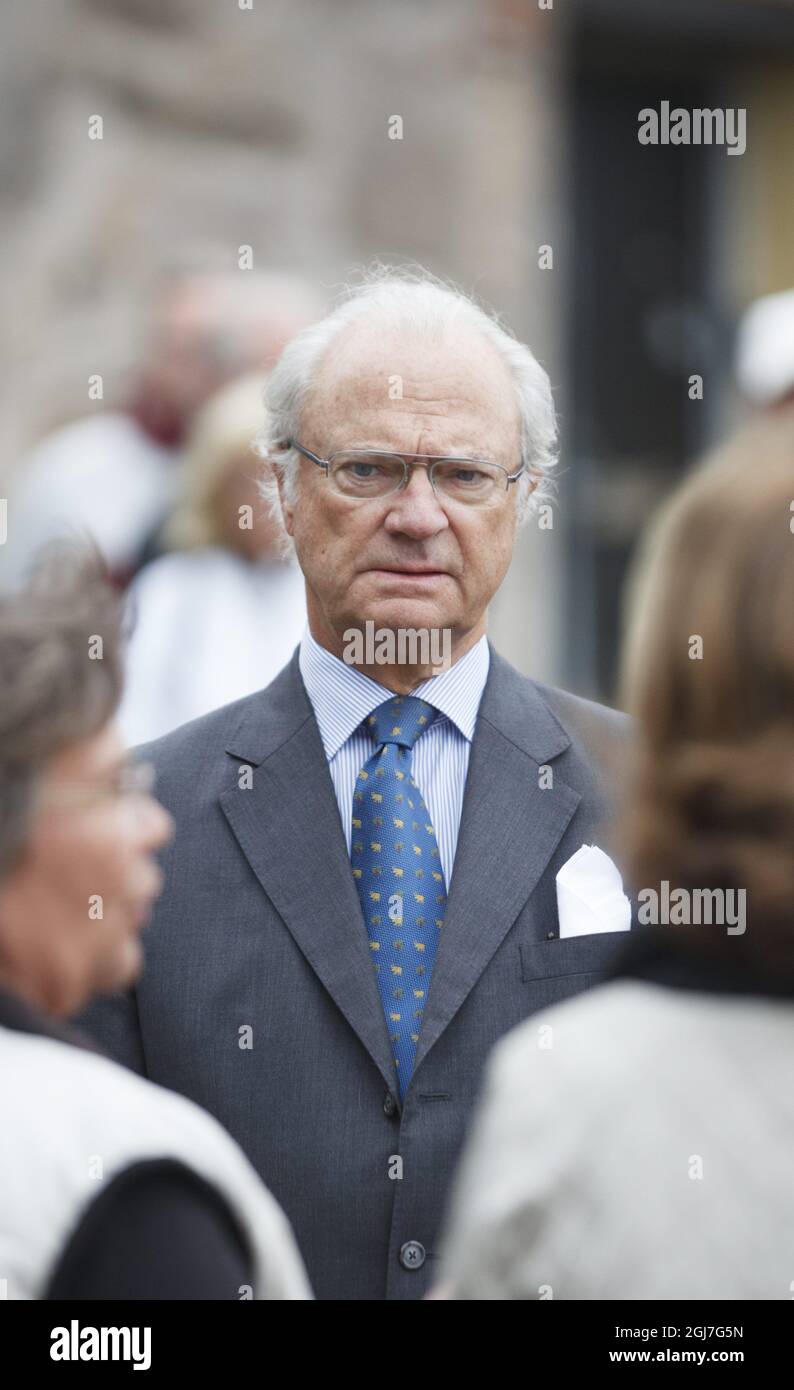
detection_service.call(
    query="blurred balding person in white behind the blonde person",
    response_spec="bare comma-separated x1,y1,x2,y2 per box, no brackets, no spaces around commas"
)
0,271,321,591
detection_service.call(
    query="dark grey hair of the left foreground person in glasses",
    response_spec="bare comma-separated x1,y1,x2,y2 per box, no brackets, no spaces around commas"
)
0,545,122,880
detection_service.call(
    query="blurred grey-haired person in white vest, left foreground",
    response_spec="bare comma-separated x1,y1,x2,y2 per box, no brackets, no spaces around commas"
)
0,555,309,1300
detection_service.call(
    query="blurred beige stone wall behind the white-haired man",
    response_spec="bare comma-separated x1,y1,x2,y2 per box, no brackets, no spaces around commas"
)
0,0,565,673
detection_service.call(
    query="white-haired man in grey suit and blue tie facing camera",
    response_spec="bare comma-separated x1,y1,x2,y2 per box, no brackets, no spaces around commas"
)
85,265,626,1300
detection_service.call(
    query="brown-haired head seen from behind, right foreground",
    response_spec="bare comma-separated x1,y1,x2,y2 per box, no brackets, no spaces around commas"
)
622,416,794,972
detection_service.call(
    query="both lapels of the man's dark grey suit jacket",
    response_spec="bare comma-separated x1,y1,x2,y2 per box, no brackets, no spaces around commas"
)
221,648,580,1095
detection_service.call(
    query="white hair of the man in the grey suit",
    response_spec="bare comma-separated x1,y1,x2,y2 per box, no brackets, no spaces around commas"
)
256,264,558,550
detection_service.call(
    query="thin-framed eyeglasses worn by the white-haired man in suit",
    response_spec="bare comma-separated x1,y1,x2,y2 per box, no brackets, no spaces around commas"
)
286,439,526,507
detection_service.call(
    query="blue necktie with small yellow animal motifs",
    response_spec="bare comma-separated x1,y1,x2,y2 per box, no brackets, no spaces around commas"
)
350,695,446,1099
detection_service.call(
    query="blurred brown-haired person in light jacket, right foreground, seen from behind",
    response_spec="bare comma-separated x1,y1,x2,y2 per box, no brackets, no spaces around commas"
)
439,416,794,1300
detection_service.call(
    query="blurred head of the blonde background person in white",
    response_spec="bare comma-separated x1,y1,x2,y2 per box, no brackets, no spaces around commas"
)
165,373,281,562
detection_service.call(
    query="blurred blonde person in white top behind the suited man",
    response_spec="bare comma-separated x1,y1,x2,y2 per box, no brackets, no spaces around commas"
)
120,374,306,744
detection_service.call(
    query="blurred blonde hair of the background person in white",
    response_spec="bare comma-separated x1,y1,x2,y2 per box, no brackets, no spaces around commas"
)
164,373,267,550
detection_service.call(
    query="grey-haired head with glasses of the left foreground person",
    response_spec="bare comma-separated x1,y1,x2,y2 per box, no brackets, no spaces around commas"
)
0,550,171,1015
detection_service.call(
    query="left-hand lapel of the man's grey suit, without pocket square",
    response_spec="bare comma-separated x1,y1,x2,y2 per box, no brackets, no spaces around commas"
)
221,653,398,1095
